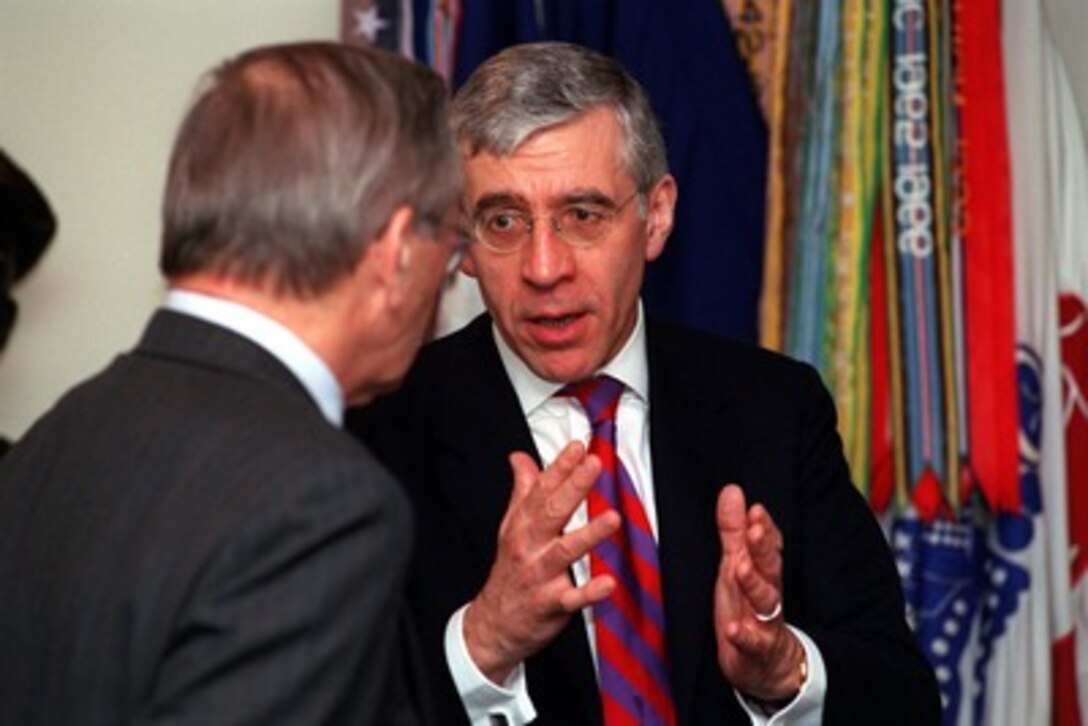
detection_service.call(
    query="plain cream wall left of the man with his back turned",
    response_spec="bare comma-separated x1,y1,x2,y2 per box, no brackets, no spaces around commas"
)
0,0,338,438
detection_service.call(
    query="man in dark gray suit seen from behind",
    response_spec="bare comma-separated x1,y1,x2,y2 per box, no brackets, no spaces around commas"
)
0,44,462,726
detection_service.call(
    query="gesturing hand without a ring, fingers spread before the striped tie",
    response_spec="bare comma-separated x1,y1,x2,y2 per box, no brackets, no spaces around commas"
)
465,442,619,682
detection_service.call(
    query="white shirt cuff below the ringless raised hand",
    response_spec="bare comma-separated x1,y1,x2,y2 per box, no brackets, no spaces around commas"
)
445,605,536,726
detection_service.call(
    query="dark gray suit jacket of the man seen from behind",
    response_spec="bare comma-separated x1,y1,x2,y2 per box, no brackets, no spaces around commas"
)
0,312,424,726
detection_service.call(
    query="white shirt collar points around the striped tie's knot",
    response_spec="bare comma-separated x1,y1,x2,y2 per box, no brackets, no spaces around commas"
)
492,300,650,416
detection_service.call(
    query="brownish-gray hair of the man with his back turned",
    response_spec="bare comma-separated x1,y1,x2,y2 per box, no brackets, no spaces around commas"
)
160,42,461,298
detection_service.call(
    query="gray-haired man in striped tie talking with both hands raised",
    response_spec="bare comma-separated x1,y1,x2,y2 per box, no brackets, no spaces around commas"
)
349,42,940,726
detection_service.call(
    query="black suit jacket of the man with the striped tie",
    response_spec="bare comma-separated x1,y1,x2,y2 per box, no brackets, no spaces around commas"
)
349,317,939,726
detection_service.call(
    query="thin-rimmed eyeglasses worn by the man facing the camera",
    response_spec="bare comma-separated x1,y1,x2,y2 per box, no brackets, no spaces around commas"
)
473,190,639,255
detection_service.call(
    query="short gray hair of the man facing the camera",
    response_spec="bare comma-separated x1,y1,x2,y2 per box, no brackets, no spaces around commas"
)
452,42,668,192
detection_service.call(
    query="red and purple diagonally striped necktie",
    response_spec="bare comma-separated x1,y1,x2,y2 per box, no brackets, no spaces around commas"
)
562,376,676,726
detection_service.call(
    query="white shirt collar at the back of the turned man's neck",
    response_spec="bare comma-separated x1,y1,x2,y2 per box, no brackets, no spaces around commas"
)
163,290,344,427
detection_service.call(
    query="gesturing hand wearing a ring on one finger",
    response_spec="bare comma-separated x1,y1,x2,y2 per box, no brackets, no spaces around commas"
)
714,484,804,700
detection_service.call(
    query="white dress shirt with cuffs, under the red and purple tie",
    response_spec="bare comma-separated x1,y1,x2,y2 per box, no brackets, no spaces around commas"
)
445,305,827,726
